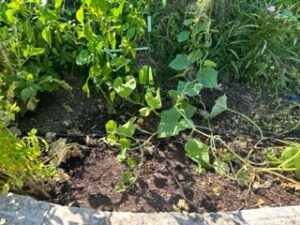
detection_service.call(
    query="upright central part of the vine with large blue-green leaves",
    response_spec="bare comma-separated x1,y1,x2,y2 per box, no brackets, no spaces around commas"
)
158,4,227,138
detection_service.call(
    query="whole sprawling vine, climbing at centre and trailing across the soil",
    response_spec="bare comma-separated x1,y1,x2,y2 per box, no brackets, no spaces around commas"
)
106,1,300,192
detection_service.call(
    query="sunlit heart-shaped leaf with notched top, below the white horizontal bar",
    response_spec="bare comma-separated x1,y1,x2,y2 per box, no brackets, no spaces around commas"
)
113,76,136,98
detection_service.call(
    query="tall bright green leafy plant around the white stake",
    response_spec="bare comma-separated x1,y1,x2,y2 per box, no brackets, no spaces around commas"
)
75,0,146,101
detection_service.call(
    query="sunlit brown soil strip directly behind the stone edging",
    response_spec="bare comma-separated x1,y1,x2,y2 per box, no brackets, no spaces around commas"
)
51,141,300,213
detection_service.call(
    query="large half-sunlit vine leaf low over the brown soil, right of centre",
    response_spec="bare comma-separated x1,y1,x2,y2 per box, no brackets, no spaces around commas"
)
184,139,211,168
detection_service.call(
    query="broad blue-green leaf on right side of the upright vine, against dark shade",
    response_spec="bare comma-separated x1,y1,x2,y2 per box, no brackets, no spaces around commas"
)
197,67,218,88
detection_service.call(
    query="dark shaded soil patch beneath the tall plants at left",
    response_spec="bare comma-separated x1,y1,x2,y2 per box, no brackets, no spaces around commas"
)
19,74,106,135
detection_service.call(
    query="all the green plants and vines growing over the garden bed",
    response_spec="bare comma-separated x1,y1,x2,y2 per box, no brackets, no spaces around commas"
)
0,0,300,195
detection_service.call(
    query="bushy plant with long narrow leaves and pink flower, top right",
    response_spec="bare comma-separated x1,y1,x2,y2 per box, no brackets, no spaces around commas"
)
210,1,299,88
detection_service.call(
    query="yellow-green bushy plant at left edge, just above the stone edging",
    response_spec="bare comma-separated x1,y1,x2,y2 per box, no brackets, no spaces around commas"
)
0,128,57,197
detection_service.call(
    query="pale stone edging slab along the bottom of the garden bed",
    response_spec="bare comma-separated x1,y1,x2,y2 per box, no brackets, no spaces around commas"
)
0,194,300,225
